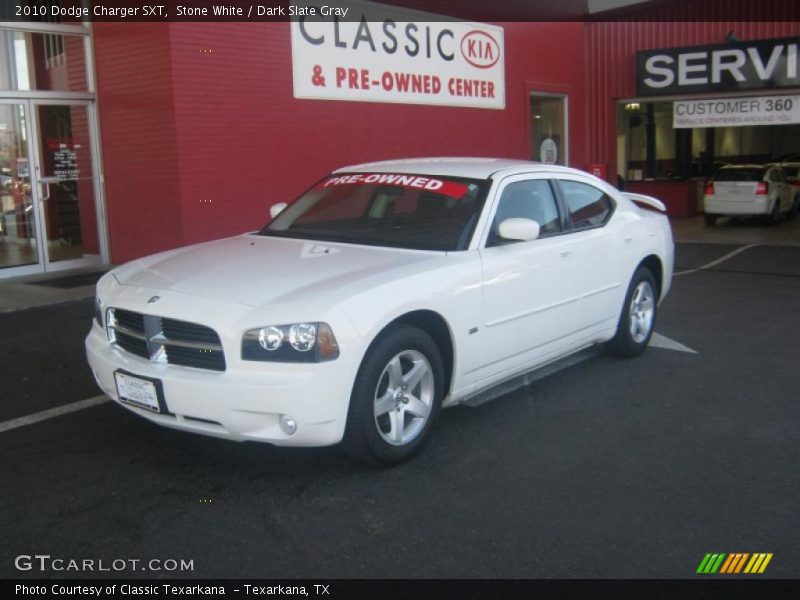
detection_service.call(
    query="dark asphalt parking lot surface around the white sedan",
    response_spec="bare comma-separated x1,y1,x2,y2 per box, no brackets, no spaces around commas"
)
0,243,800,578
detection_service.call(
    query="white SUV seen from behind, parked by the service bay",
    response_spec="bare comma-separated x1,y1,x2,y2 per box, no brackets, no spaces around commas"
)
703,165,797,225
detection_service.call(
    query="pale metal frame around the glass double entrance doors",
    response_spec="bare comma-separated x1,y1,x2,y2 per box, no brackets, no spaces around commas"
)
0,96,110,280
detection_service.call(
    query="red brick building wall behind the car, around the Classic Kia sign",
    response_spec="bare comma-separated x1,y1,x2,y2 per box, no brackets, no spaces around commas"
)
94,23,587,263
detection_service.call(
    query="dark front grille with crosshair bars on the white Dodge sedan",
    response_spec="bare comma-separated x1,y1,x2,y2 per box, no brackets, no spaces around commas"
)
107,308,225,371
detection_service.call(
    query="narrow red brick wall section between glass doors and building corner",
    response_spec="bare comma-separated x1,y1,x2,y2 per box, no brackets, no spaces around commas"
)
93,23,183,263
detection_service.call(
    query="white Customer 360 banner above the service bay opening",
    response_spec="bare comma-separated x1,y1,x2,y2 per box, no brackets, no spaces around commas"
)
672,95,800,129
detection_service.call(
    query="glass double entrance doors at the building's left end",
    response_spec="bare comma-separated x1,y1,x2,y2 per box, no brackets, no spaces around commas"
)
0,100,103,278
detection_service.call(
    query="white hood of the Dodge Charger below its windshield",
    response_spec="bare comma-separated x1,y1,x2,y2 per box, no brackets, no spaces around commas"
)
114,234,444,307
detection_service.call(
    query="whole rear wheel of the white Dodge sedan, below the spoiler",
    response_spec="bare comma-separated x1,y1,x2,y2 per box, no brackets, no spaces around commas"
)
606,267,658,356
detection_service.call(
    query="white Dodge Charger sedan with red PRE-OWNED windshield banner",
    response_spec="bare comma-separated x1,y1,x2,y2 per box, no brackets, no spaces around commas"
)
86,158,674,464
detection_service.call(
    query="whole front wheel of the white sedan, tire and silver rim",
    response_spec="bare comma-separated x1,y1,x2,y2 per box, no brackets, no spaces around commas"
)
342,325,444,466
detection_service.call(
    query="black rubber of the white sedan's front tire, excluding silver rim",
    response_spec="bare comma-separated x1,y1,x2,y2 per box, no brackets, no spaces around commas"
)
343,325,444,465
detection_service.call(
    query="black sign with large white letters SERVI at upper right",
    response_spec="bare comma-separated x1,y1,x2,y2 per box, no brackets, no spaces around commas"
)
636,38,800,96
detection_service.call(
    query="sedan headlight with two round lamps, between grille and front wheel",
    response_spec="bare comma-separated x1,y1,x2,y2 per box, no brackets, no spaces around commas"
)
242,323,339,362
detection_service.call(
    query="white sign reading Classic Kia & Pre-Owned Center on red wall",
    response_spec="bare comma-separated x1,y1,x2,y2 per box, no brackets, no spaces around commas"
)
291,3,505,109
